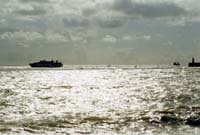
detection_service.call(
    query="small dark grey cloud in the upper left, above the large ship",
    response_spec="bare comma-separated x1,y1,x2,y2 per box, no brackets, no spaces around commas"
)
15,6,47,16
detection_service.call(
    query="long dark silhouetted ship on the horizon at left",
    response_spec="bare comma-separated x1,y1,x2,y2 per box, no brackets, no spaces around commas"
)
29,60,63,68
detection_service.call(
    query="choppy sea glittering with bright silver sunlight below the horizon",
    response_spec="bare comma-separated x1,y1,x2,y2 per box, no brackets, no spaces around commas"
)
0,66,200,135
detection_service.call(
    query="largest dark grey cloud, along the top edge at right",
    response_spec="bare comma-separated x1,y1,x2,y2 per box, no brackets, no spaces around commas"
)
113,0,187,18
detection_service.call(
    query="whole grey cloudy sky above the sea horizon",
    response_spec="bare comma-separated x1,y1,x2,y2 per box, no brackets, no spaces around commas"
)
0,0,200,65
